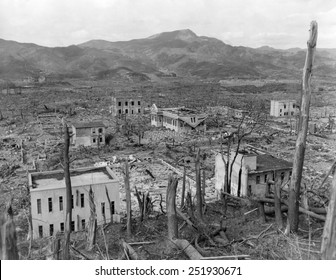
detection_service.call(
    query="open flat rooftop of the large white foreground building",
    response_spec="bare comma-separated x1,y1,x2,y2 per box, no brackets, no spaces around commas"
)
30,167,116,191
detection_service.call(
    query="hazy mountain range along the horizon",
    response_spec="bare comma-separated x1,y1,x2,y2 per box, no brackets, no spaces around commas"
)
0,29,336,81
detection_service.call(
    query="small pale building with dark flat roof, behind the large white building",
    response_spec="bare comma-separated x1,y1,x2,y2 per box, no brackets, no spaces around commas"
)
71,121,106,147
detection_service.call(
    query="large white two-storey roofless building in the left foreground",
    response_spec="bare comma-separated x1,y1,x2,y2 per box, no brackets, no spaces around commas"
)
28,166,120,238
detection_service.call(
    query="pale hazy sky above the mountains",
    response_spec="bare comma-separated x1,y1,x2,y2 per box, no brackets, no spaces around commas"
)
0,0,336,48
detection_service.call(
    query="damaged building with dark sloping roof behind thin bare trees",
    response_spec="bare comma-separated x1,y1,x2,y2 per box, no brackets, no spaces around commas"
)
215,149,293,197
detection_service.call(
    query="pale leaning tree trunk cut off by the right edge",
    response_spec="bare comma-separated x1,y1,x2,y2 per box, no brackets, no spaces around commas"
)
321,167,336,260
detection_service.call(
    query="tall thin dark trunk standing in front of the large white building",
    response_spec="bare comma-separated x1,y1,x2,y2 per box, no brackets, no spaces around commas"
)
63,123,72,260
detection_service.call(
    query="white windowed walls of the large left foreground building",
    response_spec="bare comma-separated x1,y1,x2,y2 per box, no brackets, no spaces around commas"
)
30,182,120,238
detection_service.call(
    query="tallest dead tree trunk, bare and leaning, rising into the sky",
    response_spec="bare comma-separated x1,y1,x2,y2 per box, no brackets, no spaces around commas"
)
287,21,317,232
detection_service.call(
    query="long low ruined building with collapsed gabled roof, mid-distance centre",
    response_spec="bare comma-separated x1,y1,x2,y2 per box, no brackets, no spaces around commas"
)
151,104,207,132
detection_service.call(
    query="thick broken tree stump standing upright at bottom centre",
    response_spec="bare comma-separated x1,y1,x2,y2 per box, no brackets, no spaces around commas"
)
166,175,178,239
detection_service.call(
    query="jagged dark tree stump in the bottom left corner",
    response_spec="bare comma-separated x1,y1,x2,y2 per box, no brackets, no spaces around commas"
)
0,204,19,260
